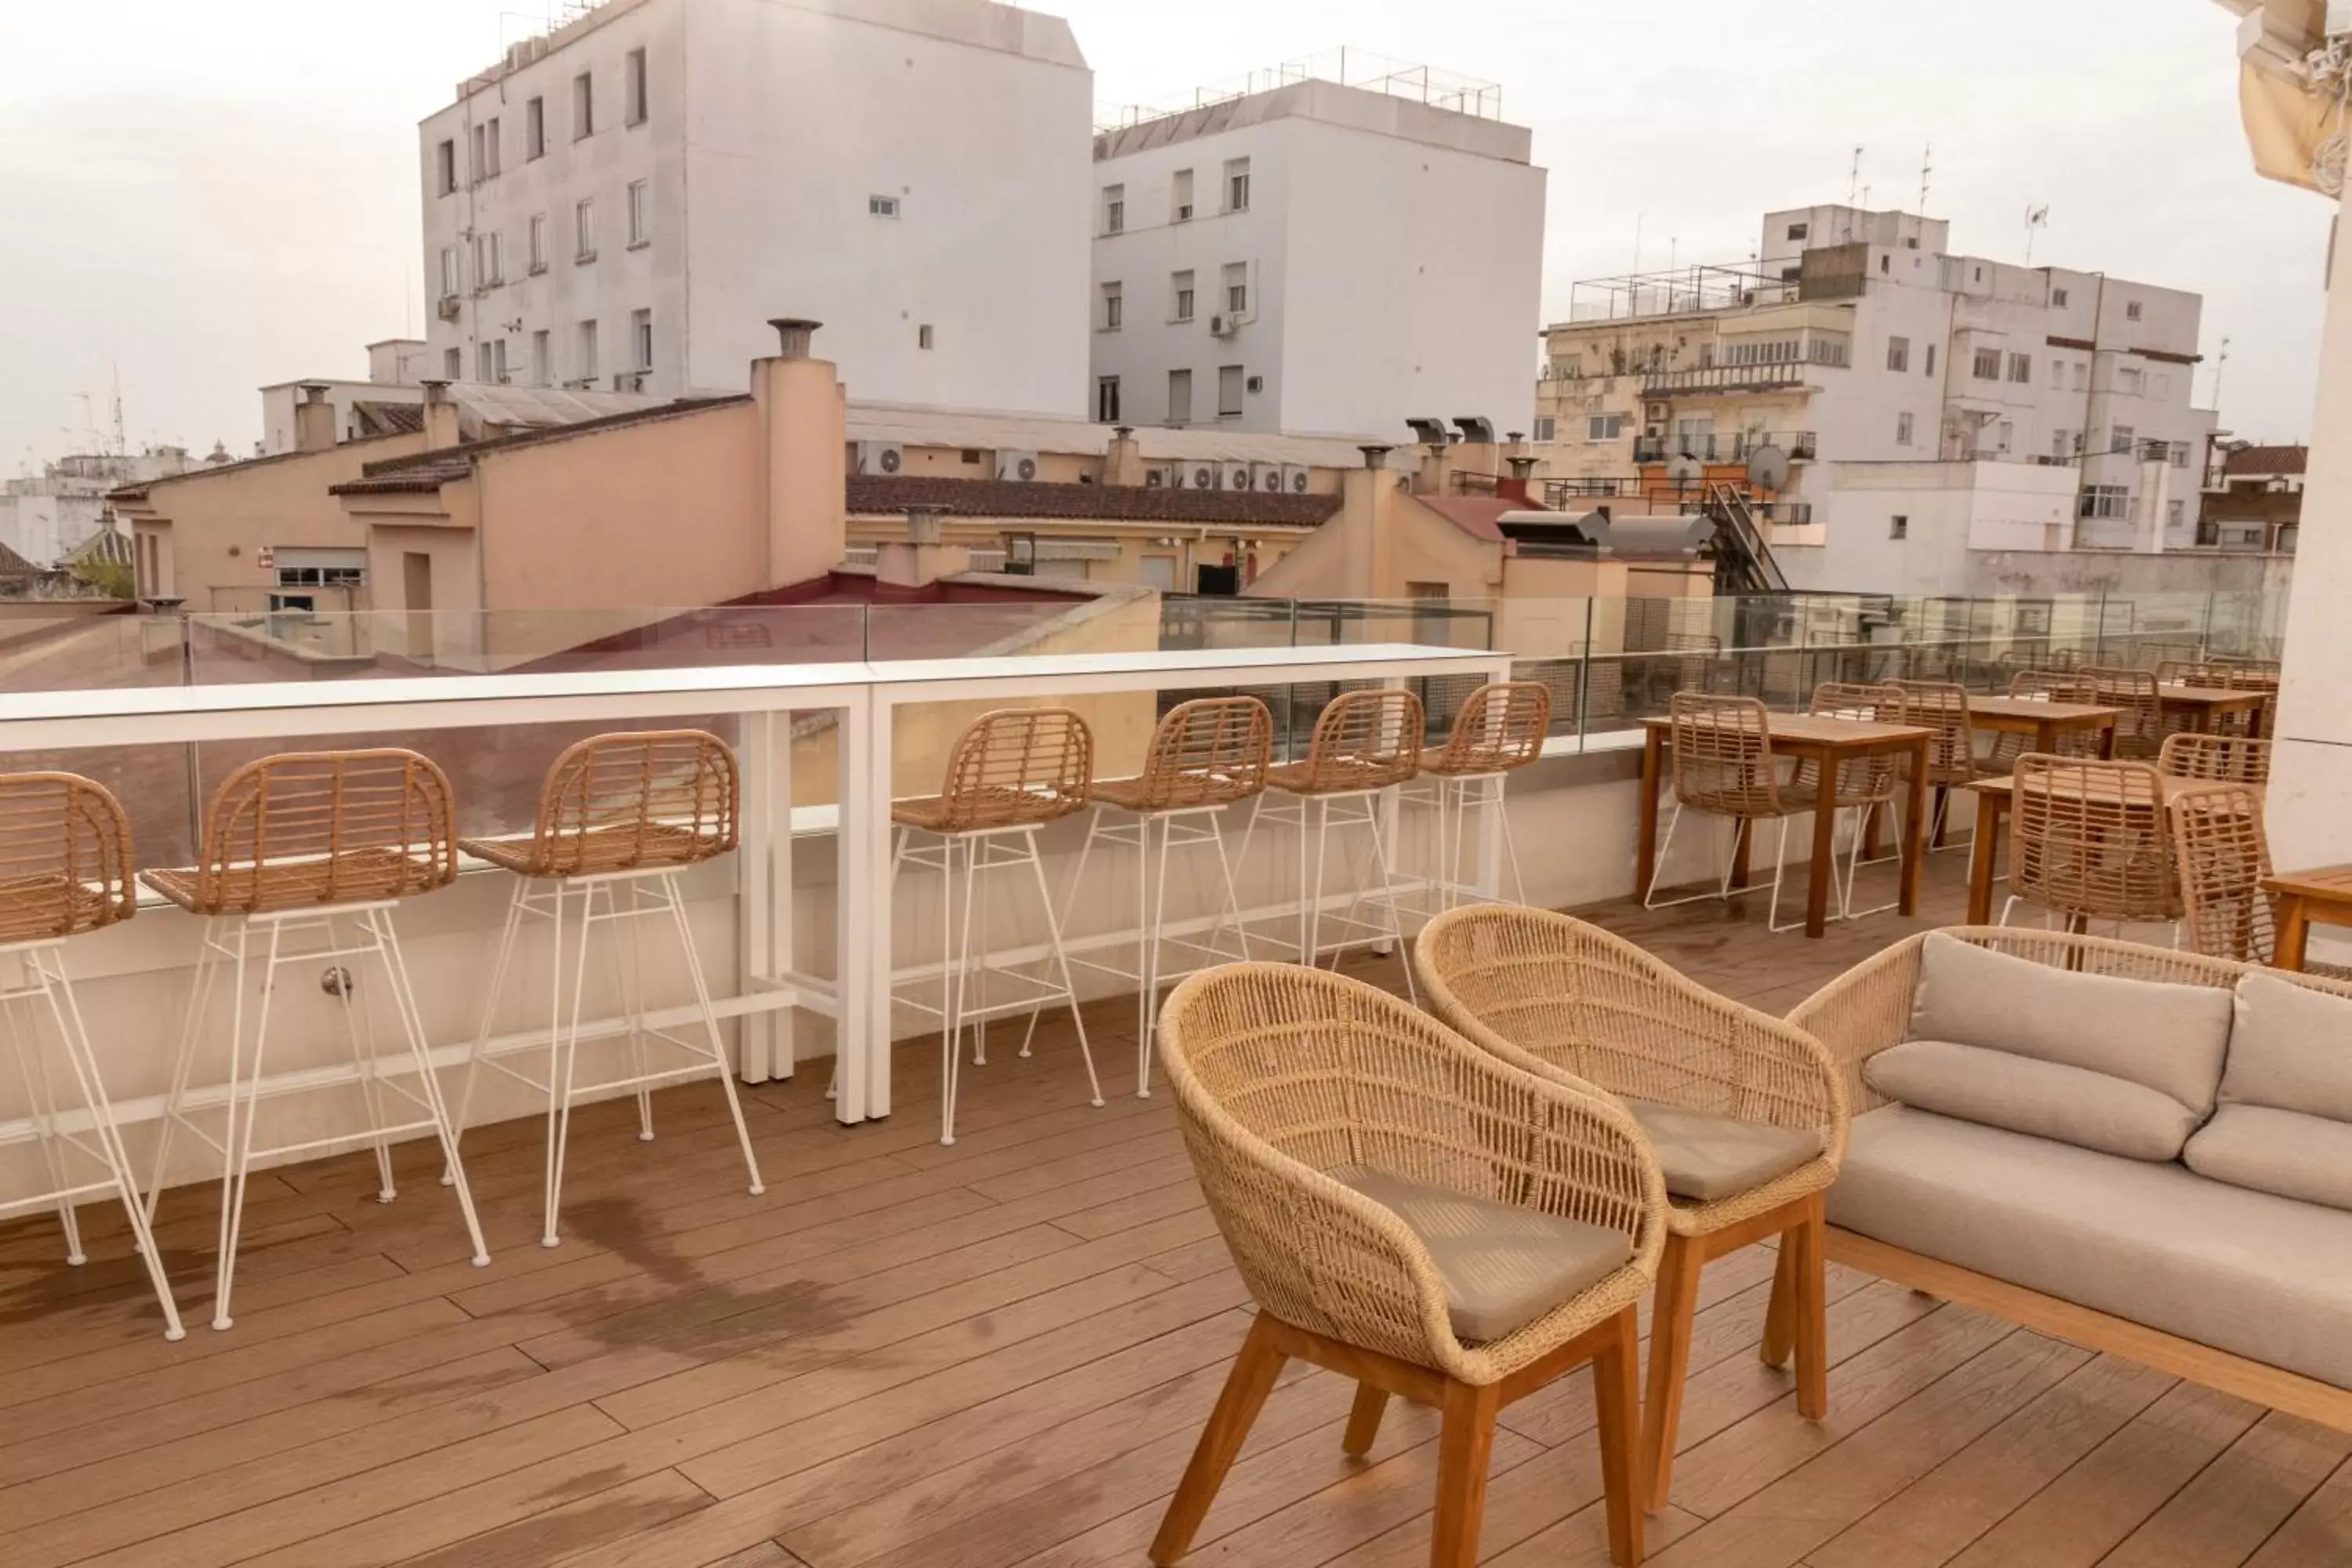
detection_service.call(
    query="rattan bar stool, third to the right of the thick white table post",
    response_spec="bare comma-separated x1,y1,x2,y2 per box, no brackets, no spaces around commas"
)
1211,687,1423,987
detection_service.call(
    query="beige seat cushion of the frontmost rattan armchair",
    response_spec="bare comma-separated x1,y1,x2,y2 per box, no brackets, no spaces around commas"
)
1331,1166,1632,1345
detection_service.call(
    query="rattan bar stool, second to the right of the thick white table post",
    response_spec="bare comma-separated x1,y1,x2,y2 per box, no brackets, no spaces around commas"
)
1054,696,1275,1098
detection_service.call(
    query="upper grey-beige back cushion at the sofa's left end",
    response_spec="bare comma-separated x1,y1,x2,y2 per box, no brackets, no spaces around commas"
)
1910,931,2234,1119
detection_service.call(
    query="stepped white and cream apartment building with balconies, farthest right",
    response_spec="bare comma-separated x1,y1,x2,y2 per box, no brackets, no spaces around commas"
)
1536,207,2213,593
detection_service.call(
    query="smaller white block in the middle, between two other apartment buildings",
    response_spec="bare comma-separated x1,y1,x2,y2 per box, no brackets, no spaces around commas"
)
1089,73,1545,442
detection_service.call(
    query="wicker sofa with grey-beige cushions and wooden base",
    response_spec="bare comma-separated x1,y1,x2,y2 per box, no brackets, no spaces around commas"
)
1790,928,2352,1429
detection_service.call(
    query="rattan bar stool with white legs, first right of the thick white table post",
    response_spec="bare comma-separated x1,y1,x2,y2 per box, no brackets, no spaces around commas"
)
891,708,1103,1142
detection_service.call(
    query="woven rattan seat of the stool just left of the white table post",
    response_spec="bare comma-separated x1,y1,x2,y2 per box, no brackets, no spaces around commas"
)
532,729,743,877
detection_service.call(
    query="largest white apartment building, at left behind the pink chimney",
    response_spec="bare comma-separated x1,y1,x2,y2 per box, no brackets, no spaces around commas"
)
419,0,1094,416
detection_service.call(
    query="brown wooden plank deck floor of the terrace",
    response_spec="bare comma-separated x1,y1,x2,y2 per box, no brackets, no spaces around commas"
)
0,855,2352,1568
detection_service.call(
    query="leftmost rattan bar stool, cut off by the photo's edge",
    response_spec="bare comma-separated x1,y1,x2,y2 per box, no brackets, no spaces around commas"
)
0,774,188,1340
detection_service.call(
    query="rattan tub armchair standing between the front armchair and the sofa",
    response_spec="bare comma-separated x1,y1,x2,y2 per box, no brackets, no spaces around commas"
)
1414,907,1849,1507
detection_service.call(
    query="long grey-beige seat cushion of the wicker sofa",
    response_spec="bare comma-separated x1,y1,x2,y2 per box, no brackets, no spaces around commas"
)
1830,1105,2352,1387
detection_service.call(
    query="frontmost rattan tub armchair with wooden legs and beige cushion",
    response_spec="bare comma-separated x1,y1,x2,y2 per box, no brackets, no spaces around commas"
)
1150,964,1665,1568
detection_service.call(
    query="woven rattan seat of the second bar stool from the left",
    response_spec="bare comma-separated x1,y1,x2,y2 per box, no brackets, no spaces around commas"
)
195,748,456,914
